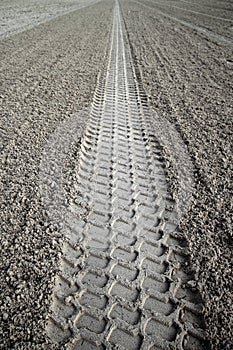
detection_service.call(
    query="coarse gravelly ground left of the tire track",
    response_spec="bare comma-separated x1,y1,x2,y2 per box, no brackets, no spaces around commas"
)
0,1,112,350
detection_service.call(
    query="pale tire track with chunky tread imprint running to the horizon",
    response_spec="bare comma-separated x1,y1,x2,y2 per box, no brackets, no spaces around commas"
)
47,2,207,350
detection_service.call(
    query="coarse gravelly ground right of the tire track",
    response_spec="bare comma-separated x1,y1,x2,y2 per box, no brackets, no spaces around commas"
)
122,0,233,350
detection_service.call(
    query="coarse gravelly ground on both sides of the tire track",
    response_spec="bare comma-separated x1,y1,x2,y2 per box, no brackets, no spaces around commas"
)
0,0,233,350
